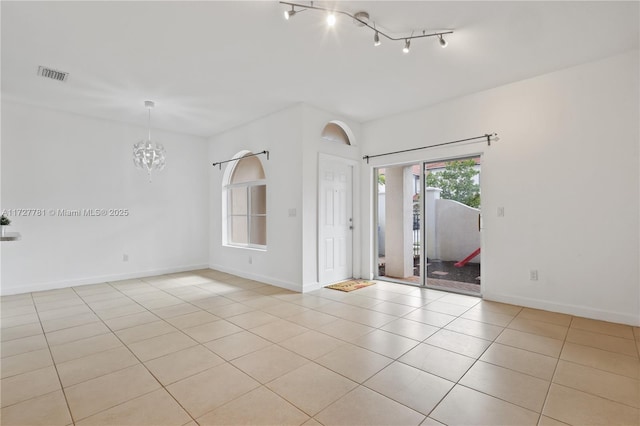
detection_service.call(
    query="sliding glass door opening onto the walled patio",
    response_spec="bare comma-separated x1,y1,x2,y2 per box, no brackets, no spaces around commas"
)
375,156,481,295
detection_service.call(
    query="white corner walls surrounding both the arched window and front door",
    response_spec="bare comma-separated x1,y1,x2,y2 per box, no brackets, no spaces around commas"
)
209,104,360,291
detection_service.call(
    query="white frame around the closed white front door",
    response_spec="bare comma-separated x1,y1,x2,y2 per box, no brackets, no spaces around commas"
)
316,152,362,287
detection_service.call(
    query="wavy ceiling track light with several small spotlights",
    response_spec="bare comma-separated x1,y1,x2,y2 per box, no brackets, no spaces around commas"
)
280,1,453,53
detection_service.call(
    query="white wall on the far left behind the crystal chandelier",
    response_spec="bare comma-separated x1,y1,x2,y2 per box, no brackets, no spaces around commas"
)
1,101,209,294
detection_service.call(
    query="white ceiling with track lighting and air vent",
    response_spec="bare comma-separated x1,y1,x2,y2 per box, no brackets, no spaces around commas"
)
1,1,640,136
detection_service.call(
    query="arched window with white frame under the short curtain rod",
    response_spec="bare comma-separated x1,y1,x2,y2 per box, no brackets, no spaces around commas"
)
225,154,267,249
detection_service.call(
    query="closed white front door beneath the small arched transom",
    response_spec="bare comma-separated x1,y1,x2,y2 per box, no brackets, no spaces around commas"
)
318,158,353,285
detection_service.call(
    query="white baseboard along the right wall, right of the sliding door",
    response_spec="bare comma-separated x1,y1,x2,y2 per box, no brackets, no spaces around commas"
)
482,291,640,326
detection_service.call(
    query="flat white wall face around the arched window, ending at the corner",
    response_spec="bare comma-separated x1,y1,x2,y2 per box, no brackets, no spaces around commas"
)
208,106,303,291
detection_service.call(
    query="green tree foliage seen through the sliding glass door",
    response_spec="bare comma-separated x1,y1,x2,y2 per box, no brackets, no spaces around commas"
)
426,159,480,208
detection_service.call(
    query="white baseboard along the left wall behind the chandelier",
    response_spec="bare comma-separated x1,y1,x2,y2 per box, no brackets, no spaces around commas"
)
0,264,209,296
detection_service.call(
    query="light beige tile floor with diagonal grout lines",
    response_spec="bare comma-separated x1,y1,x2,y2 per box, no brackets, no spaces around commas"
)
0,270,640,426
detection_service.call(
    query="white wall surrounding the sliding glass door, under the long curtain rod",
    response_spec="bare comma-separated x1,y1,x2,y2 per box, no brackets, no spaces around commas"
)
362,51,640,325
